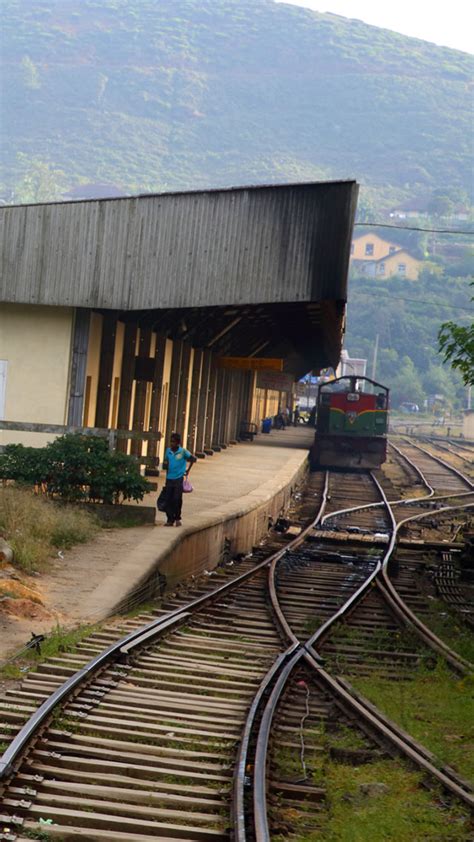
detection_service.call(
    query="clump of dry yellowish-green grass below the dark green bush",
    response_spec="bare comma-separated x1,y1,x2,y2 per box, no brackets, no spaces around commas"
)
0,486,100,572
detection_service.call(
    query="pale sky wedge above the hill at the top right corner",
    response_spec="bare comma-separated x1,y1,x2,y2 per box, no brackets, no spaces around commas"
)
277,0,474,53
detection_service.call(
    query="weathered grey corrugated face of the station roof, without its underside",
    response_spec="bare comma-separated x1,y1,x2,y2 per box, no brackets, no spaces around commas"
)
0,181,357,310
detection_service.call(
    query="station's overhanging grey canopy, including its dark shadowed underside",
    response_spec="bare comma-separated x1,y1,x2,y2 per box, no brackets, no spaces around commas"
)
0,181,358,377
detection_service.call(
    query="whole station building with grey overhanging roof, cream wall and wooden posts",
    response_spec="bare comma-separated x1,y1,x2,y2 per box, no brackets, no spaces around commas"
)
0,181,357,459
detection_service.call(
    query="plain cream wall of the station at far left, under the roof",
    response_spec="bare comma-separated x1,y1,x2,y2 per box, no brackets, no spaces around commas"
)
0,304,74,447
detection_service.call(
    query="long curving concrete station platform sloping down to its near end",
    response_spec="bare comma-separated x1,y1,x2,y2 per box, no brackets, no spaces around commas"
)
42,426,314,625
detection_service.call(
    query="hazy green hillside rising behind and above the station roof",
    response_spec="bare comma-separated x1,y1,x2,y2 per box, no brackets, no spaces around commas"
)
0,0,471,205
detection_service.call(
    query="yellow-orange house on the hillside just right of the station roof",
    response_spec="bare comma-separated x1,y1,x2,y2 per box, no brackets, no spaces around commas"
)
351,234,422,281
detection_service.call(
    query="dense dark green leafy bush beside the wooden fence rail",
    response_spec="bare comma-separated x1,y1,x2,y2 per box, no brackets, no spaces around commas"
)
0,434,150,503
